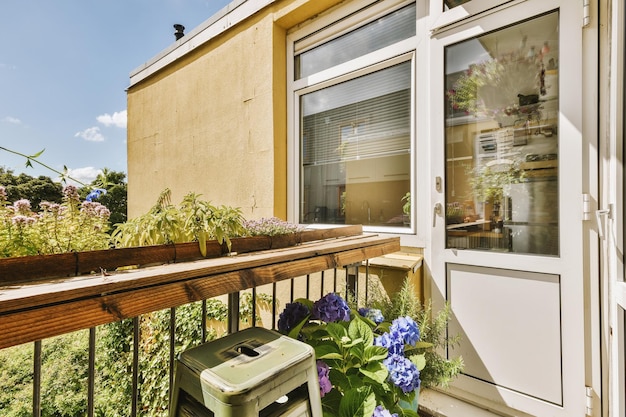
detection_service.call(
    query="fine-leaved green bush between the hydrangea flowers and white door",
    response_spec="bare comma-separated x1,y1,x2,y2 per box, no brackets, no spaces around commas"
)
372,280,463,388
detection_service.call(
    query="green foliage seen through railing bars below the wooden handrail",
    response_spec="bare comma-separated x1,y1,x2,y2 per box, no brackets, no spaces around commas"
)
0,293,271,417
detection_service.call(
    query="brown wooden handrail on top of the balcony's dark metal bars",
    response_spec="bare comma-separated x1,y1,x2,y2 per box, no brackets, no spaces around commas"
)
0,232,400,349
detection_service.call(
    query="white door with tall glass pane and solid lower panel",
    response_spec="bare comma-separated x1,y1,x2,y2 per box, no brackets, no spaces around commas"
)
429,0,595,417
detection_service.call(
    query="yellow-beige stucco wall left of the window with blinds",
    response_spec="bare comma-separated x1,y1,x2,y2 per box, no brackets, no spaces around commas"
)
128,0,339,219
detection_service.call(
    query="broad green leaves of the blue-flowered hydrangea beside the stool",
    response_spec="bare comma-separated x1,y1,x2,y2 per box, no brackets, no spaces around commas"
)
286,299,422,417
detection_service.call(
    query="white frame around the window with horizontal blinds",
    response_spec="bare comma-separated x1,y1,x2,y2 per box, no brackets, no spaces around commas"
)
287,0,417,234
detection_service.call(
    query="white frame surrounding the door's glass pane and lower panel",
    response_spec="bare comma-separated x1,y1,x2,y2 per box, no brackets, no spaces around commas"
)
426,0,599,417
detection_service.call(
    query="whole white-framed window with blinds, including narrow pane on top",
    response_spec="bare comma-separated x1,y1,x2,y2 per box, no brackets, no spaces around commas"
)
292,3,416,231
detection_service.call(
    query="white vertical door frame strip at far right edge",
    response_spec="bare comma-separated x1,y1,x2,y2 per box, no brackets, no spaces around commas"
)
597,1,626,417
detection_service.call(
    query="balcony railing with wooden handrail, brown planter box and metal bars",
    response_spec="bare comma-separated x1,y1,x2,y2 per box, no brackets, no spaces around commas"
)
0,226,400,416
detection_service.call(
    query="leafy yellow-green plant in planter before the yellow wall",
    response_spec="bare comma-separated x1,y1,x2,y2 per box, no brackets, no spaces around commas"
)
112,189,244,255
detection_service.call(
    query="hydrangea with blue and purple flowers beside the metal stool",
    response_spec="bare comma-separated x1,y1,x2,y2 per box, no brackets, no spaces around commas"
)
278,283,462,417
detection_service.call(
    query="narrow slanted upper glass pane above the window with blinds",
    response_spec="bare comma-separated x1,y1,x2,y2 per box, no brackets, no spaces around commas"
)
295,4,415,80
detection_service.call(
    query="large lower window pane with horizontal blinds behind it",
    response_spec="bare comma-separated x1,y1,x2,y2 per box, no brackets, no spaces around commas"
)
300,62,411,227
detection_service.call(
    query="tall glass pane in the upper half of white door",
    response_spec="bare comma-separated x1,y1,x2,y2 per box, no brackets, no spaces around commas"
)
445,12,559,255
